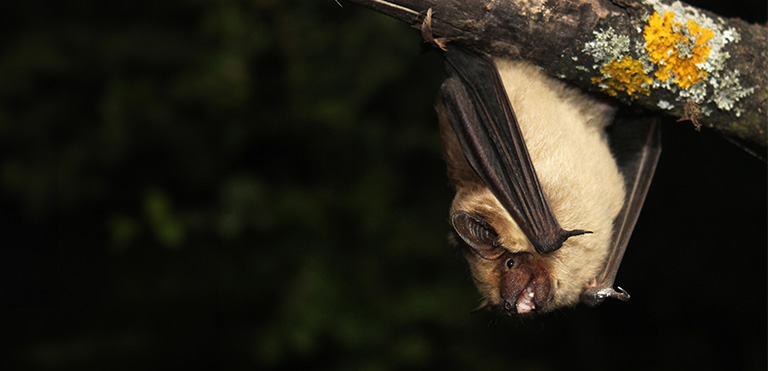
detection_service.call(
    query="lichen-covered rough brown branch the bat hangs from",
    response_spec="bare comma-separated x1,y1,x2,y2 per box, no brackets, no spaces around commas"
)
349,0,768,146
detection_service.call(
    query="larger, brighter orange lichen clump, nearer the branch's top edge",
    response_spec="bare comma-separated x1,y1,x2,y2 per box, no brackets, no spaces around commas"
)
643,12,713,89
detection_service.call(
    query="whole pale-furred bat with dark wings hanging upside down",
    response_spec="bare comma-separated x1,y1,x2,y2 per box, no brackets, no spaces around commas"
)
438,45,661,315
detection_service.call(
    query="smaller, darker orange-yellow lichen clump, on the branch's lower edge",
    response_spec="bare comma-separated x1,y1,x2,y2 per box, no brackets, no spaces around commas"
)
592,56,653,97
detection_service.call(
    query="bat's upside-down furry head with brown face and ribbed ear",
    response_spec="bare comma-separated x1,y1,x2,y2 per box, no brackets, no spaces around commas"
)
451,186,607,315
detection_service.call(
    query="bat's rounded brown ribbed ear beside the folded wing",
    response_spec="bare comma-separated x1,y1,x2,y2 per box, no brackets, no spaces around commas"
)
451,210,506,260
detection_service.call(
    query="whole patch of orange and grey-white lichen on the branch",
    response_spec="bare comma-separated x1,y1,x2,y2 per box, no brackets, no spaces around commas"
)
577,0,754,115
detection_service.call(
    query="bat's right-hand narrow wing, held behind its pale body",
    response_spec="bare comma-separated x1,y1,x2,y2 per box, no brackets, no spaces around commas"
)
581,120,661,306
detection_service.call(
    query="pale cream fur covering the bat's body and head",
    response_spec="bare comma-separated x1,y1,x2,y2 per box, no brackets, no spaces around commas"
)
441,60,625,307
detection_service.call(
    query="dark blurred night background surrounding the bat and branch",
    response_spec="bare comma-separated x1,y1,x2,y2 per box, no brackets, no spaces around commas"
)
0,0,767,370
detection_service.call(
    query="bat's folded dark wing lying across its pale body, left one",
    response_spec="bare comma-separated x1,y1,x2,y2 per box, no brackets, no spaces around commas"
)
442,46,588,253
